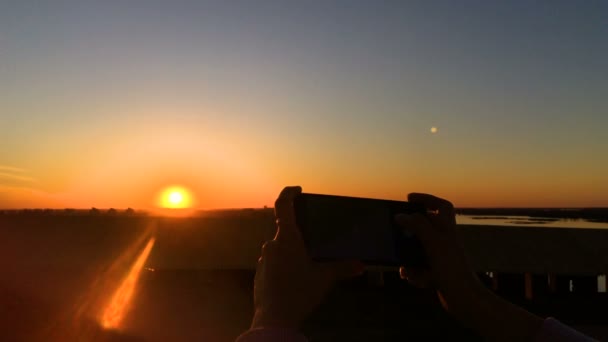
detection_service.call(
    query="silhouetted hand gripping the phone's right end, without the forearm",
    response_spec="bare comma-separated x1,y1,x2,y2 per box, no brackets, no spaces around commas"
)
396,193,483,311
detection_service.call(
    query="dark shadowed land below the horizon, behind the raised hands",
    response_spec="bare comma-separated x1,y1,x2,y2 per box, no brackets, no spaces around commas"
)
0,210,608,341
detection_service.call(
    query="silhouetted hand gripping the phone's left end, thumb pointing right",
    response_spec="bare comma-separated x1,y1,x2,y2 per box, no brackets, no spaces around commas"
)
251,186,363,329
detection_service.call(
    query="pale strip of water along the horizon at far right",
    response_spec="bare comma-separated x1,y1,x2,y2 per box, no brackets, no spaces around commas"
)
456,215,608,229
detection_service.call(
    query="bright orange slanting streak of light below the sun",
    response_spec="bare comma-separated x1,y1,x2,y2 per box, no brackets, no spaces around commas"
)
101,238,155,329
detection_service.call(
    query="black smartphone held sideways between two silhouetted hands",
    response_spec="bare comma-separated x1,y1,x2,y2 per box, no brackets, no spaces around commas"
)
294,193,426,267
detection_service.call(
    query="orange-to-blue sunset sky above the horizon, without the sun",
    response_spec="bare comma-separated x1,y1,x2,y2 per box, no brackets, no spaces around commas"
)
0,0,608,209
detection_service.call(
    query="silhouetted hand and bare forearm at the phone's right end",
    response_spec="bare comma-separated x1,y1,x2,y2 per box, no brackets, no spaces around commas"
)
396,193,543,341
